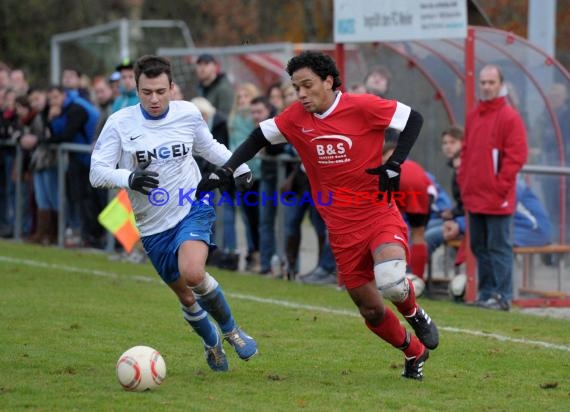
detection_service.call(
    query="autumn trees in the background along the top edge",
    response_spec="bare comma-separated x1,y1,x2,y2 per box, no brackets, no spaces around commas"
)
0,0,570,83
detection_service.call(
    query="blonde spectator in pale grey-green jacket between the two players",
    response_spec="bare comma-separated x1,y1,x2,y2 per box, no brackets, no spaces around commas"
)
227,83,261,272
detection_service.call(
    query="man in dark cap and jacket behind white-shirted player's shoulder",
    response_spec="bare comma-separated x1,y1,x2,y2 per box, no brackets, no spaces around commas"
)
196,53,234,118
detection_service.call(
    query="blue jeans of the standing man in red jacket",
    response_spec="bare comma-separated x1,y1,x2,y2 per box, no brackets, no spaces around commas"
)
469,213,514,302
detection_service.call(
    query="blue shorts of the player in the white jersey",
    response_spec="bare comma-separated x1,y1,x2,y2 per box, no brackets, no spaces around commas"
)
141,202,216,284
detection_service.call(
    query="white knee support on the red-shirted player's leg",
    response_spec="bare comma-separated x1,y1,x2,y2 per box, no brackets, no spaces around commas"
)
374,259,410,302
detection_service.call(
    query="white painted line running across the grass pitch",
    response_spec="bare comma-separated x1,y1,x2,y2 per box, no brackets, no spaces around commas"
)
4,256,570,352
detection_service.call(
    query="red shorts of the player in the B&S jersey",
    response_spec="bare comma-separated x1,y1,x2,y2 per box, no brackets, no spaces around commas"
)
329,207,410,289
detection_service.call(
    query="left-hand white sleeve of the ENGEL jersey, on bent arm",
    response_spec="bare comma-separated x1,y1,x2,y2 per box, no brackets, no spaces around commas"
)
89,122,131,188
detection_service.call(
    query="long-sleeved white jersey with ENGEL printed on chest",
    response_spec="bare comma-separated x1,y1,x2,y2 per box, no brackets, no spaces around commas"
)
89,101,249,236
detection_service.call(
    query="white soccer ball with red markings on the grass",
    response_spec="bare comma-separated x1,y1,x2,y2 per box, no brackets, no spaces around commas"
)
116,346,166,392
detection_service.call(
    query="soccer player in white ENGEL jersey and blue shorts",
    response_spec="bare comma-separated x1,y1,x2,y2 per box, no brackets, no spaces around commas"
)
90,56,257,371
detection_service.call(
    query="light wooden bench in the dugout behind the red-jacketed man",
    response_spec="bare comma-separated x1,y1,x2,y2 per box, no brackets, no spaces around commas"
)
428,239,570,298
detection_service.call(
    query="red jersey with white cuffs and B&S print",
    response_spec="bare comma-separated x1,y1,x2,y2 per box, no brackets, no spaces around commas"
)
260,92,411,234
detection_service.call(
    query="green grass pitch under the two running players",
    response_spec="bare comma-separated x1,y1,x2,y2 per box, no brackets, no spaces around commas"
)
0,241,570,412
